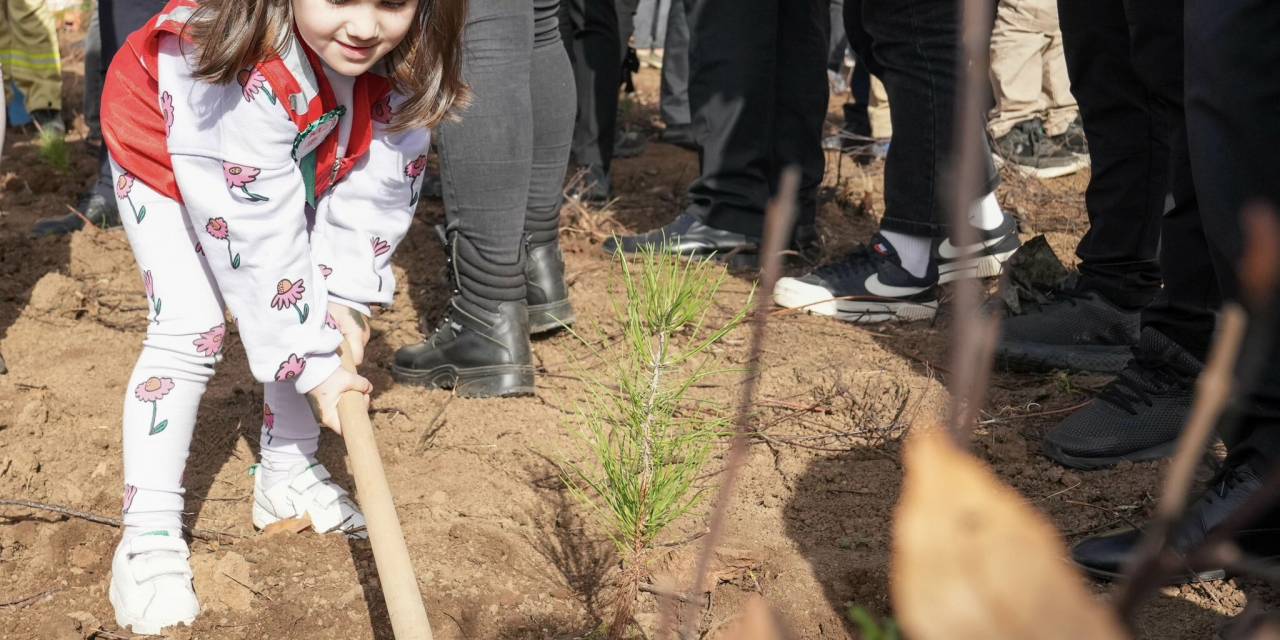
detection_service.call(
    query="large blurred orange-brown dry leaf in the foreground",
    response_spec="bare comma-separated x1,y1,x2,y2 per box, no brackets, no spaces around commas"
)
891,429,1126,640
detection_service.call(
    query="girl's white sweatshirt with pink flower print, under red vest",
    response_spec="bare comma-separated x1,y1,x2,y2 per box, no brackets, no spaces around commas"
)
157,36,430,393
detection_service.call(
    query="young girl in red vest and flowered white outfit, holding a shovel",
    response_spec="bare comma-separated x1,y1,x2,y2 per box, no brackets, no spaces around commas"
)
102,0,466,634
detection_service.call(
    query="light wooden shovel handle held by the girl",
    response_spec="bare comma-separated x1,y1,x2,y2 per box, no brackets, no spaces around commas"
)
338,344,431,640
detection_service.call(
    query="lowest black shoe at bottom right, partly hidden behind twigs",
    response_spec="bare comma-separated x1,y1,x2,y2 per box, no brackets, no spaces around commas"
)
1071,463,1280,585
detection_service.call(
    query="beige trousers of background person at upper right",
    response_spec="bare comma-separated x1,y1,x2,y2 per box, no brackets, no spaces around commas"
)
988,0,1079,138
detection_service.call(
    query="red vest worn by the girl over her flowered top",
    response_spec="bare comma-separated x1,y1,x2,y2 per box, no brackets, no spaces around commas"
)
101,0,390,205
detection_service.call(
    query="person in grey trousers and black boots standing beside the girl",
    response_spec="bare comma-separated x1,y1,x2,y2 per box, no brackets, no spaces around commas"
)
392,0,573,397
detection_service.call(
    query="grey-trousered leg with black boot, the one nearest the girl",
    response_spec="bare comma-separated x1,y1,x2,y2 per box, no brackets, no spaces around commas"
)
392,0,534,396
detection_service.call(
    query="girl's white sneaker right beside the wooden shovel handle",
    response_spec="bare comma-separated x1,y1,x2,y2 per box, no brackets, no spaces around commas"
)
253,462,369,538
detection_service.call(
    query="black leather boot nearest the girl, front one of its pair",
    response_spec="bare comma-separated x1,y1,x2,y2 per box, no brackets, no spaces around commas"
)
392,298,534,398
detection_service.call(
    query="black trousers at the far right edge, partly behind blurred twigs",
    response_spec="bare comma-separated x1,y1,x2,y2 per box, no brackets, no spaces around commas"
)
1185,0,1280,472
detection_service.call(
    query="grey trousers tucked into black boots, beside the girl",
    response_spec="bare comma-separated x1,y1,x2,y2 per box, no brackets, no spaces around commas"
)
436,0,576,310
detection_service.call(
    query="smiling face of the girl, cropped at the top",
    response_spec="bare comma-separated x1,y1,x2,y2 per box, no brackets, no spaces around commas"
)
291,0,419,76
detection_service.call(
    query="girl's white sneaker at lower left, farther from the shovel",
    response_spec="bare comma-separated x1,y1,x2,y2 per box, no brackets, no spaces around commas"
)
108,531,200,634
